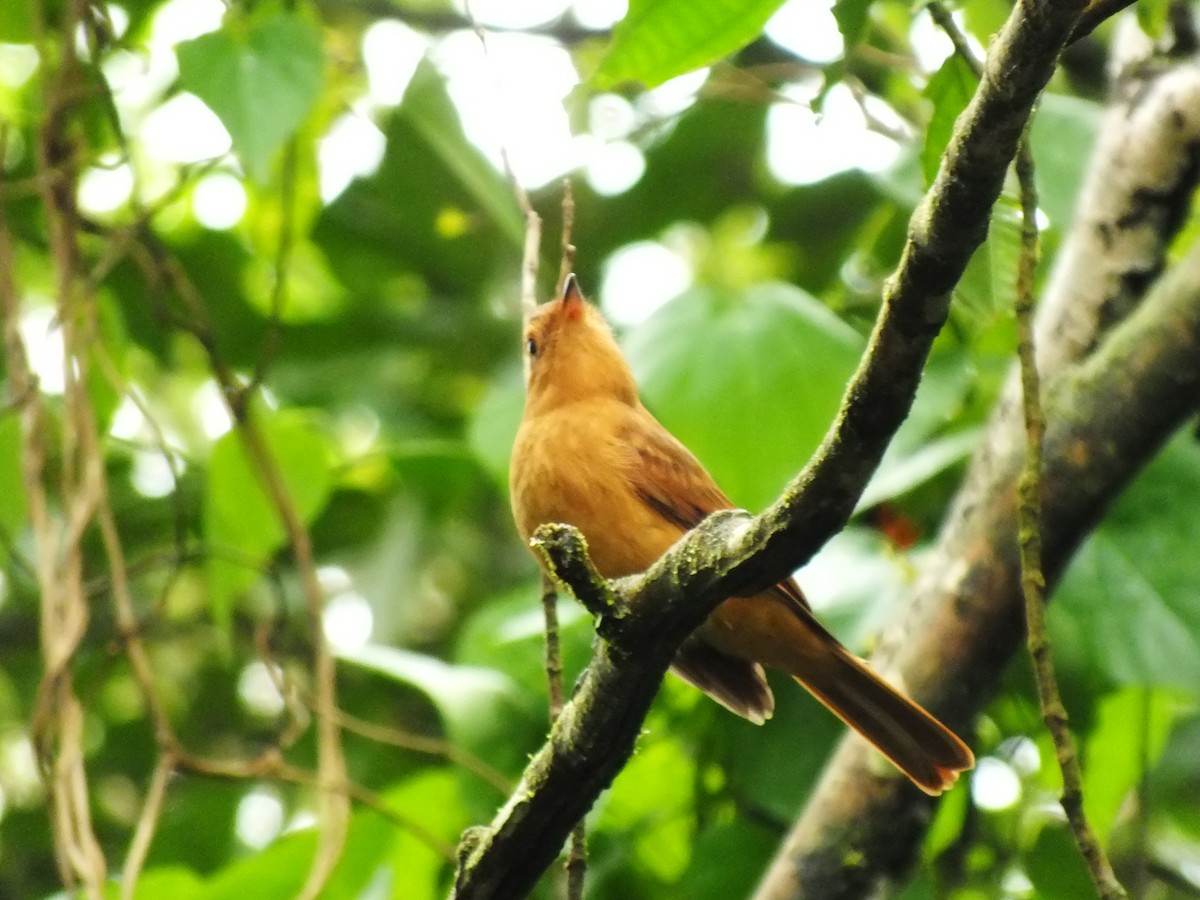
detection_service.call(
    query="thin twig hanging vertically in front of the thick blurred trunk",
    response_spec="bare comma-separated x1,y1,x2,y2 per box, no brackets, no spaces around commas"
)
1015,130,1126,900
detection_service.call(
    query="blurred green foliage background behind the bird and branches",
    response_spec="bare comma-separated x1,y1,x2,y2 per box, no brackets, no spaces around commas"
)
0,0,1200,900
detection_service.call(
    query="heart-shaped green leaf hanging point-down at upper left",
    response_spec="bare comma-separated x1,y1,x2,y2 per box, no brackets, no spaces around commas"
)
175,13,324,182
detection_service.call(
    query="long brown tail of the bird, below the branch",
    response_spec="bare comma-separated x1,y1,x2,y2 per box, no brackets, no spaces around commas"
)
793,637,974,796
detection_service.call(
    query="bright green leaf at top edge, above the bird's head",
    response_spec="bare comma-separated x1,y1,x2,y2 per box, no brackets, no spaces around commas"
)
593,0,784,90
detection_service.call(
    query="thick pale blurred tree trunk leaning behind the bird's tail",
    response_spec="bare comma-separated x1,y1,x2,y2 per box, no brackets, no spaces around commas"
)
757,30,1200,900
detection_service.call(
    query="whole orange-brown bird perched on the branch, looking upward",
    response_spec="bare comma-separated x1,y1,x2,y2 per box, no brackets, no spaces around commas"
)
510,276,974,794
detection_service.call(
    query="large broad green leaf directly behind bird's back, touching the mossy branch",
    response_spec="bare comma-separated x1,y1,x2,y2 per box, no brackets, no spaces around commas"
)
625,283,864,510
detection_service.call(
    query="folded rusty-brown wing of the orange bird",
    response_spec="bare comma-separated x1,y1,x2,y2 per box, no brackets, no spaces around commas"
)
620,408,810,617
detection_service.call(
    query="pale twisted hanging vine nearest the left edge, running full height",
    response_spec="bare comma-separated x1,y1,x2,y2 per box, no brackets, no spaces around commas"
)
25,4,106,900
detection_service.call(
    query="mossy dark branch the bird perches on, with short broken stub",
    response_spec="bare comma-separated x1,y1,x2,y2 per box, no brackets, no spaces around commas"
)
455,0,1084,899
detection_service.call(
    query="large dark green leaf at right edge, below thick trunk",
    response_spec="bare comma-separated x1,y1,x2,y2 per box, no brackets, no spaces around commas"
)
1048,434,1200,695
